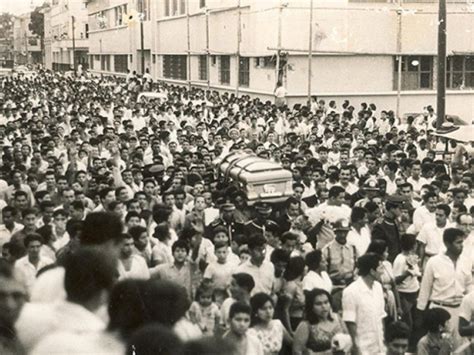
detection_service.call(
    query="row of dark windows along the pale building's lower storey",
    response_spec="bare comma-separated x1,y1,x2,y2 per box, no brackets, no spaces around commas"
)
90,54,474,90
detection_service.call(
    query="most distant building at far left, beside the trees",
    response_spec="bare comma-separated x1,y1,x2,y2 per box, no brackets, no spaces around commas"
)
13,12,43,64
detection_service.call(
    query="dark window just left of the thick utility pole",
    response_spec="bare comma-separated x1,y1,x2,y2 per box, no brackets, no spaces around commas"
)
393,56,433,90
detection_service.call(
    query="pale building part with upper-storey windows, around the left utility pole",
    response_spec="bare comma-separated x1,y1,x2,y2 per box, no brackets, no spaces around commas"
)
87,0,155,75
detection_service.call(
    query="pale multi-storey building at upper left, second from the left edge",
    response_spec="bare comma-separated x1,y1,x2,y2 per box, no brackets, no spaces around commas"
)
43,0,89,71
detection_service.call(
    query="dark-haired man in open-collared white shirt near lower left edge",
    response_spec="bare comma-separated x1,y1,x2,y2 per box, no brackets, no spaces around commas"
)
15,233,53,290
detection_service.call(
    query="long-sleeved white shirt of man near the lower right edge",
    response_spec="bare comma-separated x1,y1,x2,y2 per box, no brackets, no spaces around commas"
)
417,254,472,310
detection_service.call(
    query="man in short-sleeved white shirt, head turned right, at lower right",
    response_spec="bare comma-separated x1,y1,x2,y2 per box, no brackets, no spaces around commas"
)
342,253,386,354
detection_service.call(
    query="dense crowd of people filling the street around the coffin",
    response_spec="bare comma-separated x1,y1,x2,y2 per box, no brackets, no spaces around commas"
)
0,70,474,355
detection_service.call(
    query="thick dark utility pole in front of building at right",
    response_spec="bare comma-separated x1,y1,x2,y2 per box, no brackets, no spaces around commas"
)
436,0,447,129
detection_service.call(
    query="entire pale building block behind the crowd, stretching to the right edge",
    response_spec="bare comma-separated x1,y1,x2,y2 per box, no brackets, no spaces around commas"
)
87,0,474,119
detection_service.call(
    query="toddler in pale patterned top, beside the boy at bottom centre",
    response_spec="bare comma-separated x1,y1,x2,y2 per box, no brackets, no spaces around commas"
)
188,283,220,336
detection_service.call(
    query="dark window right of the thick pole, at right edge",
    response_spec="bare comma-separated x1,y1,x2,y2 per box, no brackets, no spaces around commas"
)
446,55,474,89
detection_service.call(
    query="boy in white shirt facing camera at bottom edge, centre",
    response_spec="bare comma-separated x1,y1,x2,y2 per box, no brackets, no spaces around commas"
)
223,302,264,355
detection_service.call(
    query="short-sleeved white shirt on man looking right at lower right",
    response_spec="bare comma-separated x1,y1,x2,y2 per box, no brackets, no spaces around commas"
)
342,277,386,355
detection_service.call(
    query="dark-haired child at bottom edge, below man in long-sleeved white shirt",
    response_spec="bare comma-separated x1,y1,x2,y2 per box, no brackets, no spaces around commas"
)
416,308,452,355
